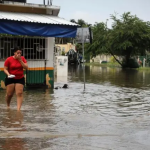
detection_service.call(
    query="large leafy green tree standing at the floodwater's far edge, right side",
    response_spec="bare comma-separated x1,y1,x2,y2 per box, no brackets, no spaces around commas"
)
88,12,150,67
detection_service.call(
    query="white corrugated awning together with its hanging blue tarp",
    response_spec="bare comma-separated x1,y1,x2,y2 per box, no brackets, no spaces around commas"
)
0,11,78,37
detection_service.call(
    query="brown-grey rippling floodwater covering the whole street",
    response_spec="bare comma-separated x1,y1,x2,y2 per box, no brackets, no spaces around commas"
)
0,66,150,150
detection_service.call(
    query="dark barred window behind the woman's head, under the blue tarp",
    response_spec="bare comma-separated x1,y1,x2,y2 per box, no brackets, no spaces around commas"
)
0,36,47,60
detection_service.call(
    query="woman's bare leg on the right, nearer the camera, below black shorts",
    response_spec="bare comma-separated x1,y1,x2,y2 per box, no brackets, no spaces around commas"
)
15,83,23,111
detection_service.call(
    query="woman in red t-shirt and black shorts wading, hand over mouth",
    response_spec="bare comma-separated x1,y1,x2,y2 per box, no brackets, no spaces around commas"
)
4,47,28,110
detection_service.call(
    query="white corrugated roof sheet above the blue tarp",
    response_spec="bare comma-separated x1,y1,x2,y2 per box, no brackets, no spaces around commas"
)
0,11,78,26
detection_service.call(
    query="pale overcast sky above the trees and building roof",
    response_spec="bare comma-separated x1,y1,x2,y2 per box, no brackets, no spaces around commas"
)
27,0,150,26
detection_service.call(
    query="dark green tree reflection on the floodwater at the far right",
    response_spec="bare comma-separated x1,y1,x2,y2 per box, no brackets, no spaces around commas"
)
69,66,150,88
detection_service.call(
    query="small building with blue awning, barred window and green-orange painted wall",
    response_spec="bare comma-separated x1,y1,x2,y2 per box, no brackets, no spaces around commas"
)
0,1,78,89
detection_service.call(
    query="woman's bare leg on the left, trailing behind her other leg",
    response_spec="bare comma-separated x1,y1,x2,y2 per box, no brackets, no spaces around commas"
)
6,84,15,108
